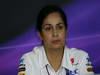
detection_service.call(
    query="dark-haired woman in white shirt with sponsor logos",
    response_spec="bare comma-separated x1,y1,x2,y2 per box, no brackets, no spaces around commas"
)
18,5,94,75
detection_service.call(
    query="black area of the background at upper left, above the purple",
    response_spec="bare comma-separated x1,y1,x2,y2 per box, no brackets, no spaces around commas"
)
0,0,73,45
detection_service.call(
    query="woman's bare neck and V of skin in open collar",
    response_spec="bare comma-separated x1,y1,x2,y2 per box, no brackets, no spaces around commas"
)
45,48,64,71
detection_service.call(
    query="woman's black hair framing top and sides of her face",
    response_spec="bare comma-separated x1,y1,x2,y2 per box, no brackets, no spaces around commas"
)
36,5,67,32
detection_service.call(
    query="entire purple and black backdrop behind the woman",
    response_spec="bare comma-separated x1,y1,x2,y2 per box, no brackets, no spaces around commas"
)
0,0,100,75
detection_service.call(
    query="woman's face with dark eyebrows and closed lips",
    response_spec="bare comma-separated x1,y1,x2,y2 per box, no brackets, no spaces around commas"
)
40,12,66,49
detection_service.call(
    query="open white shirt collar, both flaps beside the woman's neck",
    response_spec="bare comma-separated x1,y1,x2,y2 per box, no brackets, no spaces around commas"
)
39,46,72,70
